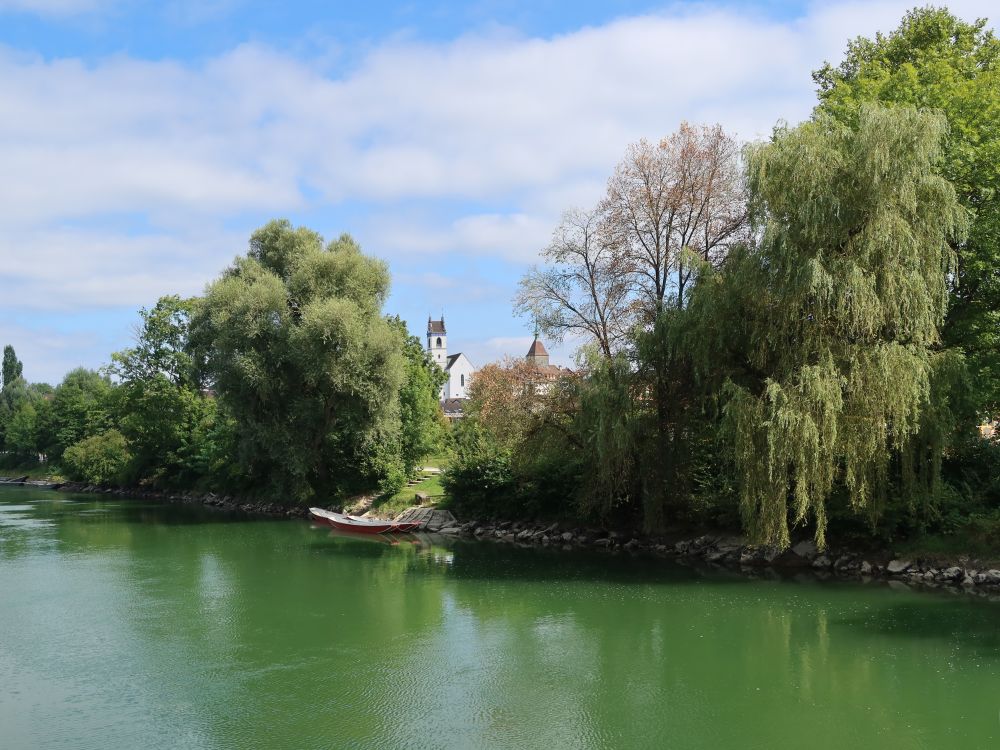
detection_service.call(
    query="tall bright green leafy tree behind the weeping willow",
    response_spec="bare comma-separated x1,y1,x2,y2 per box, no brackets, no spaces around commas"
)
813,7,1000,418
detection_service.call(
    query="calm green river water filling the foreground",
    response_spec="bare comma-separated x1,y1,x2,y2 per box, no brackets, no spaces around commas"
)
0,487,1000,750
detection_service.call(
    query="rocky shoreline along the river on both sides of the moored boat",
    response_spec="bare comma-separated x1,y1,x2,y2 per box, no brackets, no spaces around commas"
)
0,478,1000,601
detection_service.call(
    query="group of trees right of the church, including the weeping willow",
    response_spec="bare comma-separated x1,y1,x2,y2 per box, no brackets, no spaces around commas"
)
446,8,1000,546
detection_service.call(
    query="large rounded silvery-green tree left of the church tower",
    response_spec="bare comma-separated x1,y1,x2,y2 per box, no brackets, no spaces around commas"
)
191,221,406,502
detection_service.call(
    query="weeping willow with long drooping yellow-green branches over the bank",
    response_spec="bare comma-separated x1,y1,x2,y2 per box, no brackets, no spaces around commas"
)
705,106,965,547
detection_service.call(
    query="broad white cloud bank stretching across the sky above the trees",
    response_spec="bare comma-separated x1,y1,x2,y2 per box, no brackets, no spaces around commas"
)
0,0,995,376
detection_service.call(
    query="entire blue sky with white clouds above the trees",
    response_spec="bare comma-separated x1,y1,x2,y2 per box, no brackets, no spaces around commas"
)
0,0,994,382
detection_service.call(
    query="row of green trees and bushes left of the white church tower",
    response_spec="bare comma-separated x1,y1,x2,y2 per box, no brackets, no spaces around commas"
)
0,221,445,503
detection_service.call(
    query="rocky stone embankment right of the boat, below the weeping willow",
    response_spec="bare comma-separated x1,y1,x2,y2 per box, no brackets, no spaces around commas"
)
439,521,1000,598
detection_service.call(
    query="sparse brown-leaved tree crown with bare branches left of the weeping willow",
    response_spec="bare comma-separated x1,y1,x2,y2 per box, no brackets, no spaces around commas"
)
515,123,748,368
